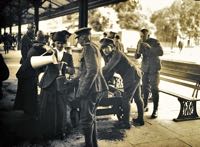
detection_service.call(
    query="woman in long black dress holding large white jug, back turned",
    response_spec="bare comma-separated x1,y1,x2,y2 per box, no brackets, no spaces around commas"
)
14,31,46,118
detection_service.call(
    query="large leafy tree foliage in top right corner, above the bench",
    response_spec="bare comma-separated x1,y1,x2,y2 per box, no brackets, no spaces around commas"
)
151,0,200,42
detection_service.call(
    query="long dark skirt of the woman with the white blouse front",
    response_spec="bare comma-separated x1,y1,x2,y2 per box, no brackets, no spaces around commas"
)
39,82,66,138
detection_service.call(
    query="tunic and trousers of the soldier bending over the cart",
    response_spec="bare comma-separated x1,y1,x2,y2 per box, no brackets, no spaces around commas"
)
103,50,143,123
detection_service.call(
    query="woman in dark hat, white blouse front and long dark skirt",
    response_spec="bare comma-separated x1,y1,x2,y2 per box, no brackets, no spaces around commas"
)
40,32,74,139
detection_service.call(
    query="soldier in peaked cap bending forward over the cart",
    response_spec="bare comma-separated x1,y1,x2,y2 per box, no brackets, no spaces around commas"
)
100,38,144,129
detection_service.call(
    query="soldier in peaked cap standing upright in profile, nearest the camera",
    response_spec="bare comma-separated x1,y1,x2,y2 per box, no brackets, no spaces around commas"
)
75,27,108,147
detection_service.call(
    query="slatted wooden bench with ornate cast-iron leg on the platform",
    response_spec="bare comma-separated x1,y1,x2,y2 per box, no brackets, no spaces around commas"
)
159,60,200,121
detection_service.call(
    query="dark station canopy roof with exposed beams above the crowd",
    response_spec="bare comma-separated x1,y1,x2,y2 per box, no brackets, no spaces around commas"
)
0,0,126,28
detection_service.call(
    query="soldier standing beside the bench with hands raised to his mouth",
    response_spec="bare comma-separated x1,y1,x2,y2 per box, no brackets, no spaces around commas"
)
135,29,163,118
